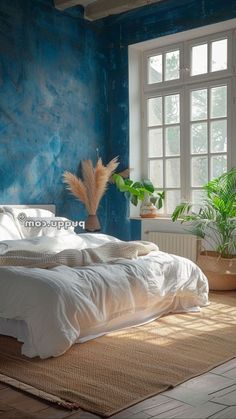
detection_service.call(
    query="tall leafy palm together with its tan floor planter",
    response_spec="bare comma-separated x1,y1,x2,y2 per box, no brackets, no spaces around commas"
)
172,168,236,290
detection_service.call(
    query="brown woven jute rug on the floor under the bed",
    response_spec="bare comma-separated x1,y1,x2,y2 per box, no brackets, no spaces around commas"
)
0,292,236,417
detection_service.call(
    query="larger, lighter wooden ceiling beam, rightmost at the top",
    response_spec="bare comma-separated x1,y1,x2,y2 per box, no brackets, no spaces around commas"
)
85,0,163,20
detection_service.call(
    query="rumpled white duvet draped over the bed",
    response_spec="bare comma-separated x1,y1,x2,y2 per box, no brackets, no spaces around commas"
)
0,234,208,358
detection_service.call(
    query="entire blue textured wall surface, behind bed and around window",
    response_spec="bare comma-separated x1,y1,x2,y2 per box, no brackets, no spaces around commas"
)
0,0,236,239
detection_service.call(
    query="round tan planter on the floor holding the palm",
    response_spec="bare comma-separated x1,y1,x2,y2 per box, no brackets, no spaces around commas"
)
197,251,236,291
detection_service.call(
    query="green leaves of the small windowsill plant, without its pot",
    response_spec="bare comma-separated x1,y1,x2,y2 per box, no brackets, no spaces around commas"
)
112,173,165,209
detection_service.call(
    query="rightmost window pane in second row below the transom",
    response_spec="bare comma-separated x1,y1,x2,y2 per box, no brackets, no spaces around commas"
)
211,120,227,153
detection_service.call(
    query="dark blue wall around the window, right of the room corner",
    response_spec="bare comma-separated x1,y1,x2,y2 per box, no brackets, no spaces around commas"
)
102,0,236,239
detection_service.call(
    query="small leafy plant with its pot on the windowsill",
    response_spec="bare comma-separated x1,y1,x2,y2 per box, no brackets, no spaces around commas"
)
112,173,165,218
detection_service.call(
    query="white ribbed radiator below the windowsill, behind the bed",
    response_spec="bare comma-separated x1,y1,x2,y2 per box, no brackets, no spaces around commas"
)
147,231,198,262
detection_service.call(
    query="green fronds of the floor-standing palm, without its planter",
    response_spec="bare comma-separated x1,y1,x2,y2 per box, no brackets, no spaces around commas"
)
172,168,236,257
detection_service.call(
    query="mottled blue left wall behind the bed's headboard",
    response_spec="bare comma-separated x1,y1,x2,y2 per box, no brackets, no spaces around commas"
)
0,0,107,228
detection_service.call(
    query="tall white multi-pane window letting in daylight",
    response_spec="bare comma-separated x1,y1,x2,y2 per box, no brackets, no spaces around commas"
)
142,31,232,215
